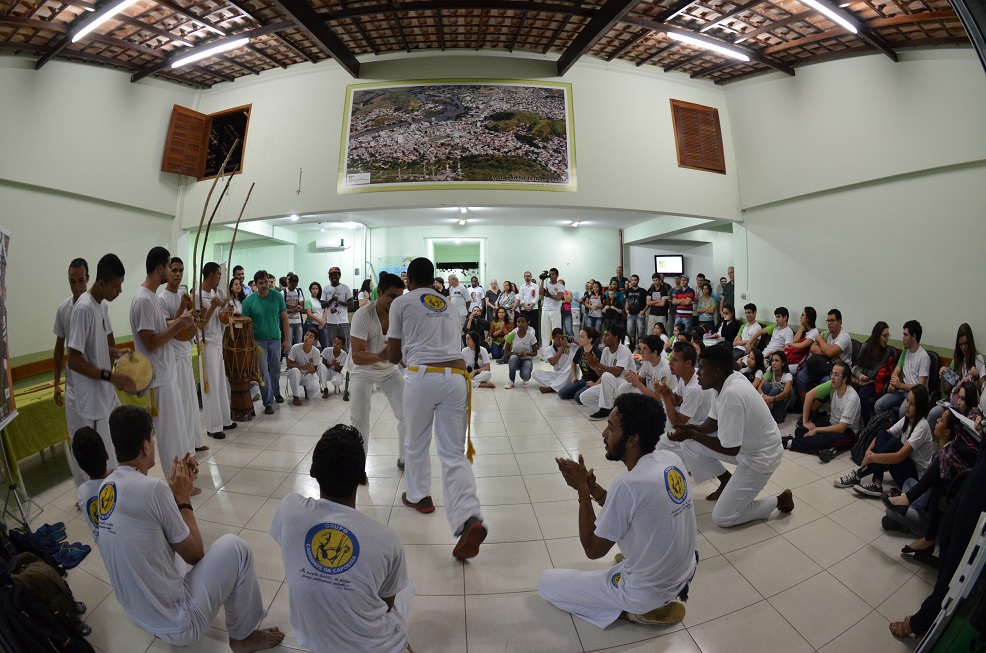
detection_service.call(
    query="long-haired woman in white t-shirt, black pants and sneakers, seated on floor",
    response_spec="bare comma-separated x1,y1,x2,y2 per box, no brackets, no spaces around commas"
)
835,385,934,497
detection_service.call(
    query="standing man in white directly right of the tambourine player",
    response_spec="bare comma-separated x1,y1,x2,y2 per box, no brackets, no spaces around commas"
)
130,247,196,476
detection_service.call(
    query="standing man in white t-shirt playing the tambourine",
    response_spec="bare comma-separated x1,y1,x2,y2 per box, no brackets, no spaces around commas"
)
68,254,137,467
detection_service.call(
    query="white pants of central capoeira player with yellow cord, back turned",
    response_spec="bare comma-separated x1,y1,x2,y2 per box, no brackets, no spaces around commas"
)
404,365,482,536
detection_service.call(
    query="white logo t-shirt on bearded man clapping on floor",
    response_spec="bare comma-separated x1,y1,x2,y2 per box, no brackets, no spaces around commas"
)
595,450,696,609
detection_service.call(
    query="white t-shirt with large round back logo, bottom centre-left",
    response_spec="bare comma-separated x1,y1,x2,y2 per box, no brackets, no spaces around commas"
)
270,494,410,653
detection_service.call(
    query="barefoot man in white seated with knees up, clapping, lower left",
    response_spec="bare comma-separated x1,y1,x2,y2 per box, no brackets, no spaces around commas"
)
98,406,284,653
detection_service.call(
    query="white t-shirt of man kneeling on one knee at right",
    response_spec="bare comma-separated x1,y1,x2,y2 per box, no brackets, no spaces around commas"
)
709,372,784,474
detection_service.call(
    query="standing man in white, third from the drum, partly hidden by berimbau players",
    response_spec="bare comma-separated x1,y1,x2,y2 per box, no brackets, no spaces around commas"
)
158,256,205,451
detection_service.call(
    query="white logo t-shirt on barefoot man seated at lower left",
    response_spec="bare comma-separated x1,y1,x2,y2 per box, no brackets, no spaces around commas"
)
97,466,192,635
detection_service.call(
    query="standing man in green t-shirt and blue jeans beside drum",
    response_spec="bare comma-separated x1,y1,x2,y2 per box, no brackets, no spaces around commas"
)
243,270,291,415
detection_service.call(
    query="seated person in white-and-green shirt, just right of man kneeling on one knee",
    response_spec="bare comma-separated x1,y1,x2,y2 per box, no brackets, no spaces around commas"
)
782,360,860,462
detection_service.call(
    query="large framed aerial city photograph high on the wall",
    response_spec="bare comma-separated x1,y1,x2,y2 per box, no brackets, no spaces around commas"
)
338,80,576,193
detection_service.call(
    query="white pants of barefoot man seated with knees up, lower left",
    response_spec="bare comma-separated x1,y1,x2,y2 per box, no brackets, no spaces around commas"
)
152,534,267,646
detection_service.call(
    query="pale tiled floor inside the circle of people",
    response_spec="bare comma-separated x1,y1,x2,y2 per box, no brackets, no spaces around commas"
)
11,366,934,653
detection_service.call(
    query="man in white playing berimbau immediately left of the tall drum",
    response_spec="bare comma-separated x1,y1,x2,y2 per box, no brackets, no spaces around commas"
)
192,261,235,440
